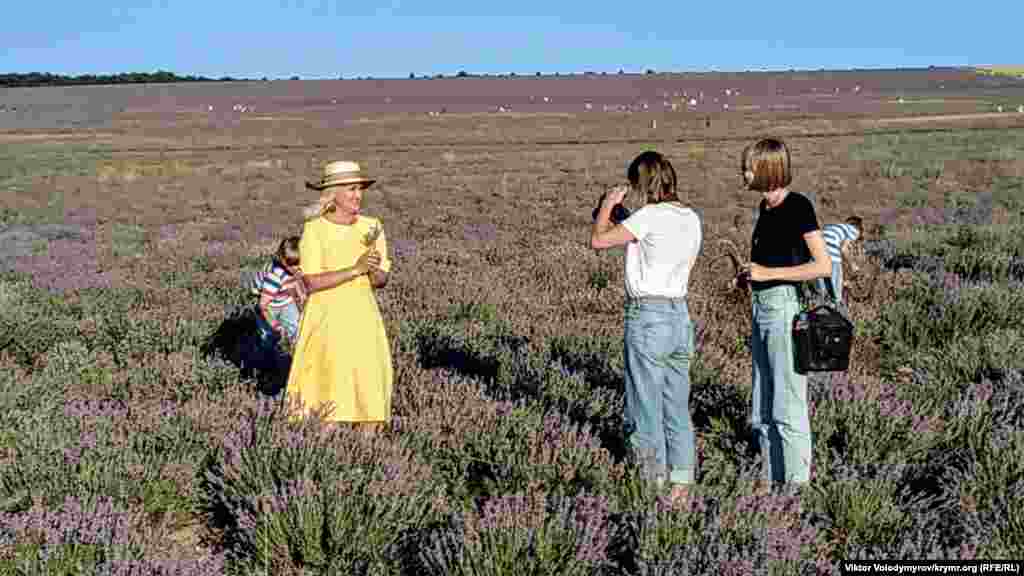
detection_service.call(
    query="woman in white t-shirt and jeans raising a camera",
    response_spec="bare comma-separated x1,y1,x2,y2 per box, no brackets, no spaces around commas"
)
590,151,702,501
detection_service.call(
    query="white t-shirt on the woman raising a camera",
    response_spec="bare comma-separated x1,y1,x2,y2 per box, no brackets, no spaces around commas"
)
622,202,702,298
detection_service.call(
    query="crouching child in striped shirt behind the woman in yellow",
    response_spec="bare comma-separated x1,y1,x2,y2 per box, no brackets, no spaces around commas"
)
259,236,305,344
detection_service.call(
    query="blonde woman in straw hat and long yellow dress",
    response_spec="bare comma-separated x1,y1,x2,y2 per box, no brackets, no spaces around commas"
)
288,161,393,431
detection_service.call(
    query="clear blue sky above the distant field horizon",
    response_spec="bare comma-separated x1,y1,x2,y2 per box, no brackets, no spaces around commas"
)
0,0,1024,78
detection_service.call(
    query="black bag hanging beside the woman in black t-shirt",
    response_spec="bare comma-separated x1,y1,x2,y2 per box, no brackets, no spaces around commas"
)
793,304,853,374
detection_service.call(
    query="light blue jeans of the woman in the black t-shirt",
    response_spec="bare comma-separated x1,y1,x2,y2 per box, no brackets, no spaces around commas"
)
751,286,811,483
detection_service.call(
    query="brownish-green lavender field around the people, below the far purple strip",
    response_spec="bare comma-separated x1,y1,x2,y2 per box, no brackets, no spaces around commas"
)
0,72,1024,576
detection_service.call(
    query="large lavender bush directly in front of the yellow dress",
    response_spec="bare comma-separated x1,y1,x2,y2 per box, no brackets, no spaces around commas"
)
203,401,447,574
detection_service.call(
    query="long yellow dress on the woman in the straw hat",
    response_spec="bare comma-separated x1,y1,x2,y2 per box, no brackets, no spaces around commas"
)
287,215,393,422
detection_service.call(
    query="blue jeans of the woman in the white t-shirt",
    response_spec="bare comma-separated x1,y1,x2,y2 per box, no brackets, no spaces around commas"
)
625,299,696,484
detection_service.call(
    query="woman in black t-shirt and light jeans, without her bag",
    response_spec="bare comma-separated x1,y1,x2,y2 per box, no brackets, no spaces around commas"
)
741,139,831,484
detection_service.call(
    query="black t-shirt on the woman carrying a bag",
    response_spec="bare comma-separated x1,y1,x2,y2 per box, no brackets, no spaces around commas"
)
751,192,819,289
